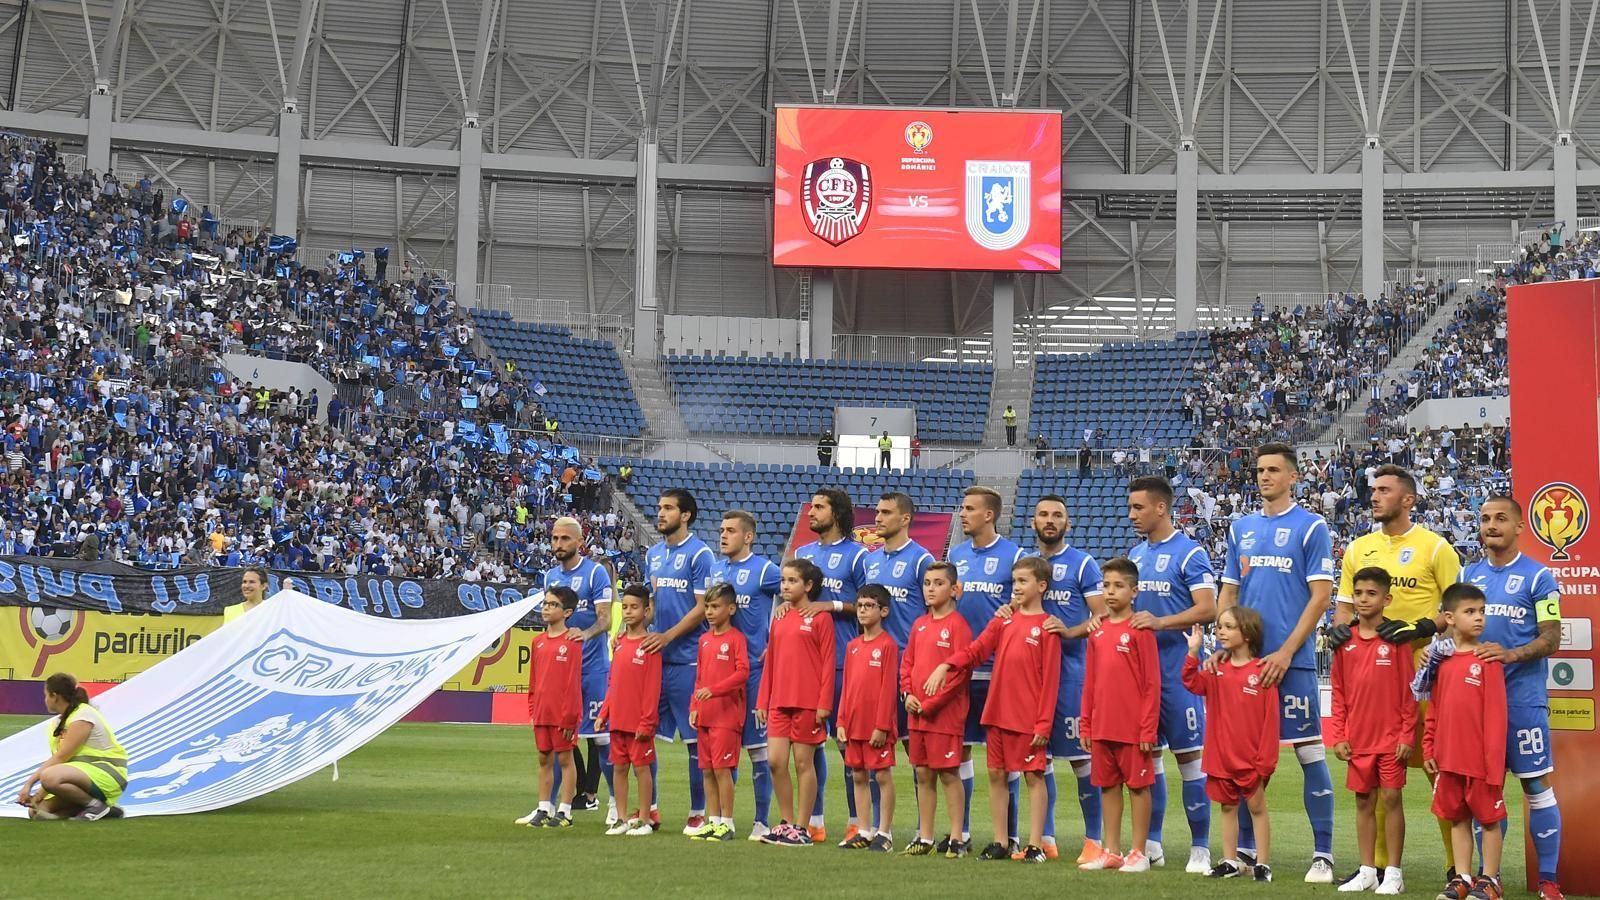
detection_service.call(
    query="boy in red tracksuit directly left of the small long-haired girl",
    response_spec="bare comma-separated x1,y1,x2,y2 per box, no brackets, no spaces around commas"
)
1078,559,1162,871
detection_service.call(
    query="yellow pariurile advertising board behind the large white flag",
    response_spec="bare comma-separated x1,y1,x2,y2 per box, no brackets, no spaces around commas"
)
0,607,536,690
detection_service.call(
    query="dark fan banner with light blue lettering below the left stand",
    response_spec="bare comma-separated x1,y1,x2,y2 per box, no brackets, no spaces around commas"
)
0,556,538,618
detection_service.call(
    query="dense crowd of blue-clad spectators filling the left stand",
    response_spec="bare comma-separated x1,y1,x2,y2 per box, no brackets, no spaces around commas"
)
0,136,638,581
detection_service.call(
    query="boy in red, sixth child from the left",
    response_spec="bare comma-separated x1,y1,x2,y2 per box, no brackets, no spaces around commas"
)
901,562,973,860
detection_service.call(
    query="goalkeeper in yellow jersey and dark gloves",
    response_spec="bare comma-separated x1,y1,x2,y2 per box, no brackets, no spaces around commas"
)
1328,464,1461,871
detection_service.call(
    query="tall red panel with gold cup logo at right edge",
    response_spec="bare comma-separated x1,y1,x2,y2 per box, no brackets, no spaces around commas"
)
1507,280,1600,895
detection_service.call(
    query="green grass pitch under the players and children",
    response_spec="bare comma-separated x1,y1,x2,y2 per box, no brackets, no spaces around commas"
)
0,716,1526,900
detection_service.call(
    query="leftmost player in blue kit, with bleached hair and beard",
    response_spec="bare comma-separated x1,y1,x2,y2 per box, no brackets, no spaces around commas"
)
530,516,616,826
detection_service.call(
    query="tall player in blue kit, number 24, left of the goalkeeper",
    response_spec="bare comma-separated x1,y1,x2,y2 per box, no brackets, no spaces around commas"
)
1218,444,1334,884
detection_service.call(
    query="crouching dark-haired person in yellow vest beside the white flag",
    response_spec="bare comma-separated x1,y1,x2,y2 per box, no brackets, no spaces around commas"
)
16,673,128,822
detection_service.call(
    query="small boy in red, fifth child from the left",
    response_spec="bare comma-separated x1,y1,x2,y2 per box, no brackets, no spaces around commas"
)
838,585,899,854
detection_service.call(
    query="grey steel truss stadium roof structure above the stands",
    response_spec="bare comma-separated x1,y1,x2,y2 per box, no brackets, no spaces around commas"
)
0,0,1600,357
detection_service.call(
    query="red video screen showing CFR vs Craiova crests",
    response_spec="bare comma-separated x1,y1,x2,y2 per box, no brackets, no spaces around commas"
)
773,106,1062,272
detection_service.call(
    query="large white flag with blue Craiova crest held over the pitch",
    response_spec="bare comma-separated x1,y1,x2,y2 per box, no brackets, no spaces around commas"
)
0,591,541,817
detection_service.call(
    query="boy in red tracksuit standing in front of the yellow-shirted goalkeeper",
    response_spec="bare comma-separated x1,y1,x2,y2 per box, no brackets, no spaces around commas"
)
1328,565,1416,892
